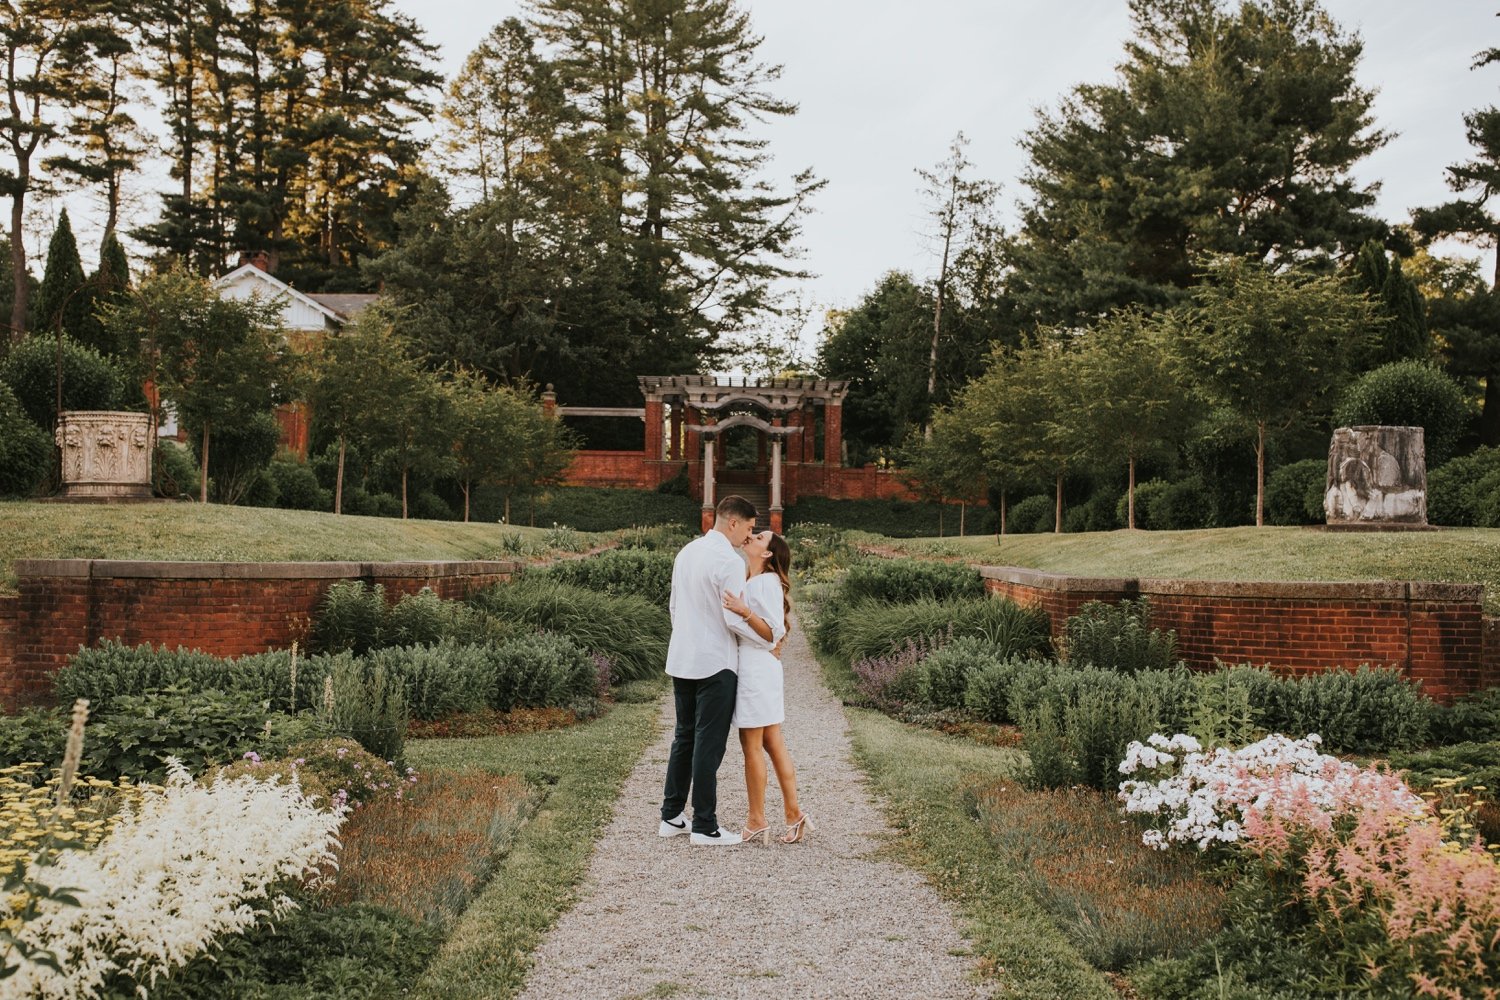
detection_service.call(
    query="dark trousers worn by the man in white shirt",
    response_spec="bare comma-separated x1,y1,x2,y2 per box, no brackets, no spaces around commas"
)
662,670,740,834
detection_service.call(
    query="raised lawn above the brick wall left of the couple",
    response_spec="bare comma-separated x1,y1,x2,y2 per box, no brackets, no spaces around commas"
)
0,501,597,594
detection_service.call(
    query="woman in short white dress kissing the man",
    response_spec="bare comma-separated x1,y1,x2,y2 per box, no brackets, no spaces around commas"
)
725,531,813,844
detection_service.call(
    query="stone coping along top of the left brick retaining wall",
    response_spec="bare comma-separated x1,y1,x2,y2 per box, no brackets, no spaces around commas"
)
12,559,524,580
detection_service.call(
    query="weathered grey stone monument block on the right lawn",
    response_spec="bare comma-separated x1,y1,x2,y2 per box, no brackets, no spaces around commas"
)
1323,427,1427,528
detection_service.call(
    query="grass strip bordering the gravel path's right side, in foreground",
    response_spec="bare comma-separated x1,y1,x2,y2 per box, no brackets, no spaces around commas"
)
822,641,1116,1000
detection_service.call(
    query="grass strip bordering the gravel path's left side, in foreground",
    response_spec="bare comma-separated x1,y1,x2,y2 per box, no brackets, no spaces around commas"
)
407,701,660,1000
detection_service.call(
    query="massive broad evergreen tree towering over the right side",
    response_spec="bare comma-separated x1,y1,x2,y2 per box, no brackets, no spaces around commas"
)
1005,0,1386,325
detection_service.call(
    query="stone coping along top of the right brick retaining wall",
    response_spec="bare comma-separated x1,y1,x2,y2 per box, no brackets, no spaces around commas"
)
977,567,1484,604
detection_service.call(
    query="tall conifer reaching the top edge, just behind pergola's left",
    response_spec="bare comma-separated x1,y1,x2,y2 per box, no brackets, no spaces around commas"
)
533,0,822,370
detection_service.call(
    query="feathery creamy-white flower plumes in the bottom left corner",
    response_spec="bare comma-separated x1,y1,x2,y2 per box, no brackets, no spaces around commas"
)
3,760,345,1000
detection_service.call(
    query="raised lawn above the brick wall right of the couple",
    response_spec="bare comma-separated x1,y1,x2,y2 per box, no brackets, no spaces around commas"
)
855,528,1500,615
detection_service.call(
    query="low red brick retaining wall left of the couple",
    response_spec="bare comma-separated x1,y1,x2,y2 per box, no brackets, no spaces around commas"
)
0,559,516,709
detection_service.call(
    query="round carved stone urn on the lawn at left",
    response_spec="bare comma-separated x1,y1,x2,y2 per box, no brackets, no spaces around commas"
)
57,409,152,501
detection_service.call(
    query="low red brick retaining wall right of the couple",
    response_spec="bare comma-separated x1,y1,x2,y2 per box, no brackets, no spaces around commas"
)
980,567,1500,702
